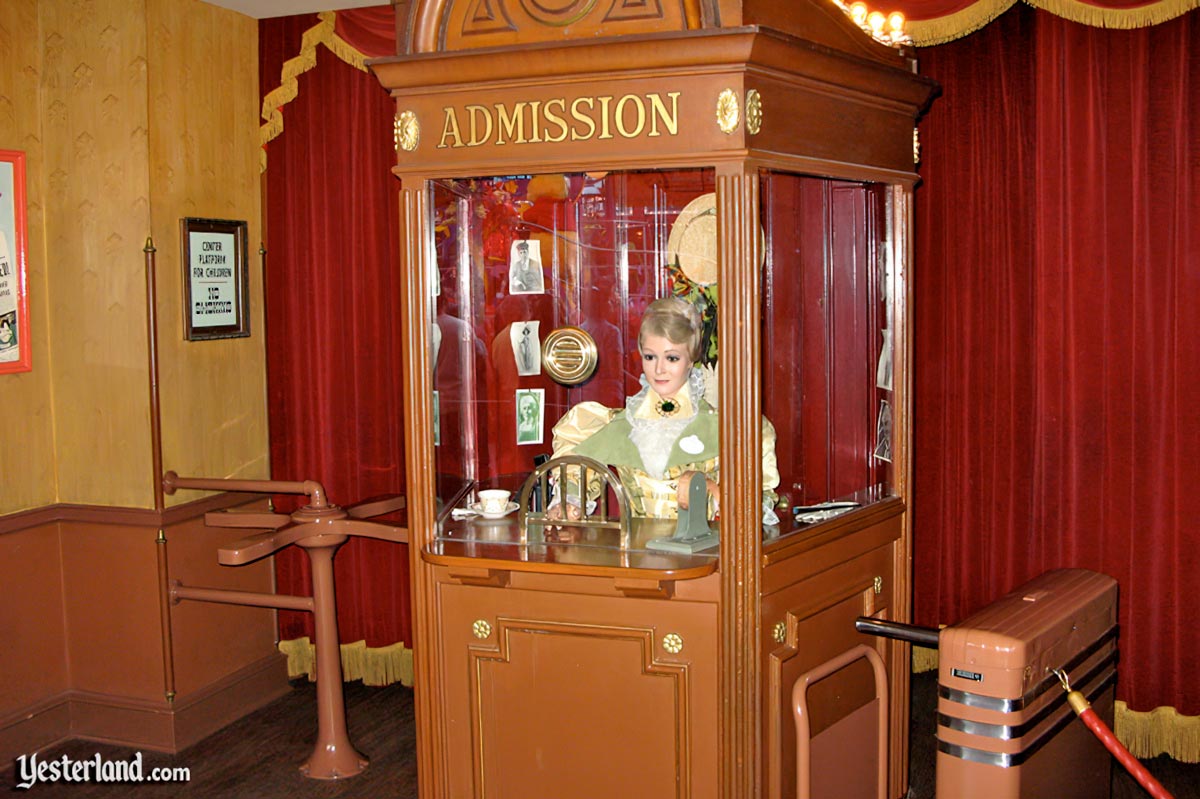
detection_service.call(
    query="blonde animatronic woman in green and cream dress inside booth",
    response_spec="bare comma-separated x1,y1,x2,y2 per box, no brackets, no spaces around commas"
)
547,298,779,524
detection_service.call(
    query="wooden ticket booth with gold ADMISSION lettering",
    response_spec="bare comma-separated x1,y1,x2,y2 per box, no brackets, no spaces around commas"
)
371,0,935,799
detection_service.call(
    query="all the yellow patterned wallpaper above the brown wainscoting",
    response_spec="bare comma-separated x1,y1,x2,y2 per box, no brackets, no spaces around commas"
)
0,0,268,513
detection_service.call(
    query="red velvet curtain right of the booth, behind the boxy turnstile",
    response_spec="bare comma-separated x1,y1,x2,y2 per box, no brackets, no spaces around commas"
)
914,6,1200,715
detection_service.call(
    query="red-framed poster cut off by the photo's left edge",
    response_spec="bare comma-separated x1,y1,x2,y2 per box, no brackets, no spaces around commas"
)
0,150,34,374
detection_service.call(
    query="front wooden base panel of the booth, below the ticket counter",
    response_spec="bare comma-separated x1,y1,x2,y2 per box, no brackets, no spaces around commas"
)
439,568,718,799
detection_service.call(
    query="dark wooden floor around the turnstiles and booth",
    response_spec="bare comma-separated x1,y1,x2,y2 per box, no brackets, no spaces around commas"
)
0,672,1200,799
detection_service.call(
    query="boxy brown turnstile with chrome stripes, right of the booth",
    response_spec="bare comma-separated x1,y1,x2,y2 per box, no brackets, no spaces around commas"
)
858,569,1117,799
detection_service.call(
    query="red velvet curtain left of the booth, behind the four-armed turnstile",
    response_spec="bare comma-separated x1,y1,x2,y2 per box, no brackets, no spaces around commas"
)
259,16,412,647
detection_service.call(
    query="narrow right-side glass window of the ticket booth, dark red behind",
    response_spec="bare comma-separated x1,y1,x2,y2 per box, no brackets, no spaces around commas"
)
761,173,894,531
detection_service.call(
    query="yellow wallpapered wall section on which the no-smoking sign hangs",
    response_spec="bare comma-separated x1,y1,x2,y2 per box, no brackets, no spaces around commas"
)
146,0,268,505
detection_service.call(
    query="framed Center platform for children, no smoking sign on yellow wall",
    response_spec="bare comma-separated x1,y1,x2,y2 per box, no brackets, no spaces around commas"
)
180,217,250,341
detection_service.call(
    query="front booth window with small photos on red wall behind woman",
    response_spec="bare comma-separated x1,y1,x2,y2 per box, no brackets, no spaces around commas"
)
431,169,714,513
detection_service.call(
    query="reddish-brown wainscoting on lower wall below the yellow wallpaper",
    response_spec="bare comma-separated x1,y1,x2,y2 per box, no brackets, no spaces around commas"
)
0,494,288,762
